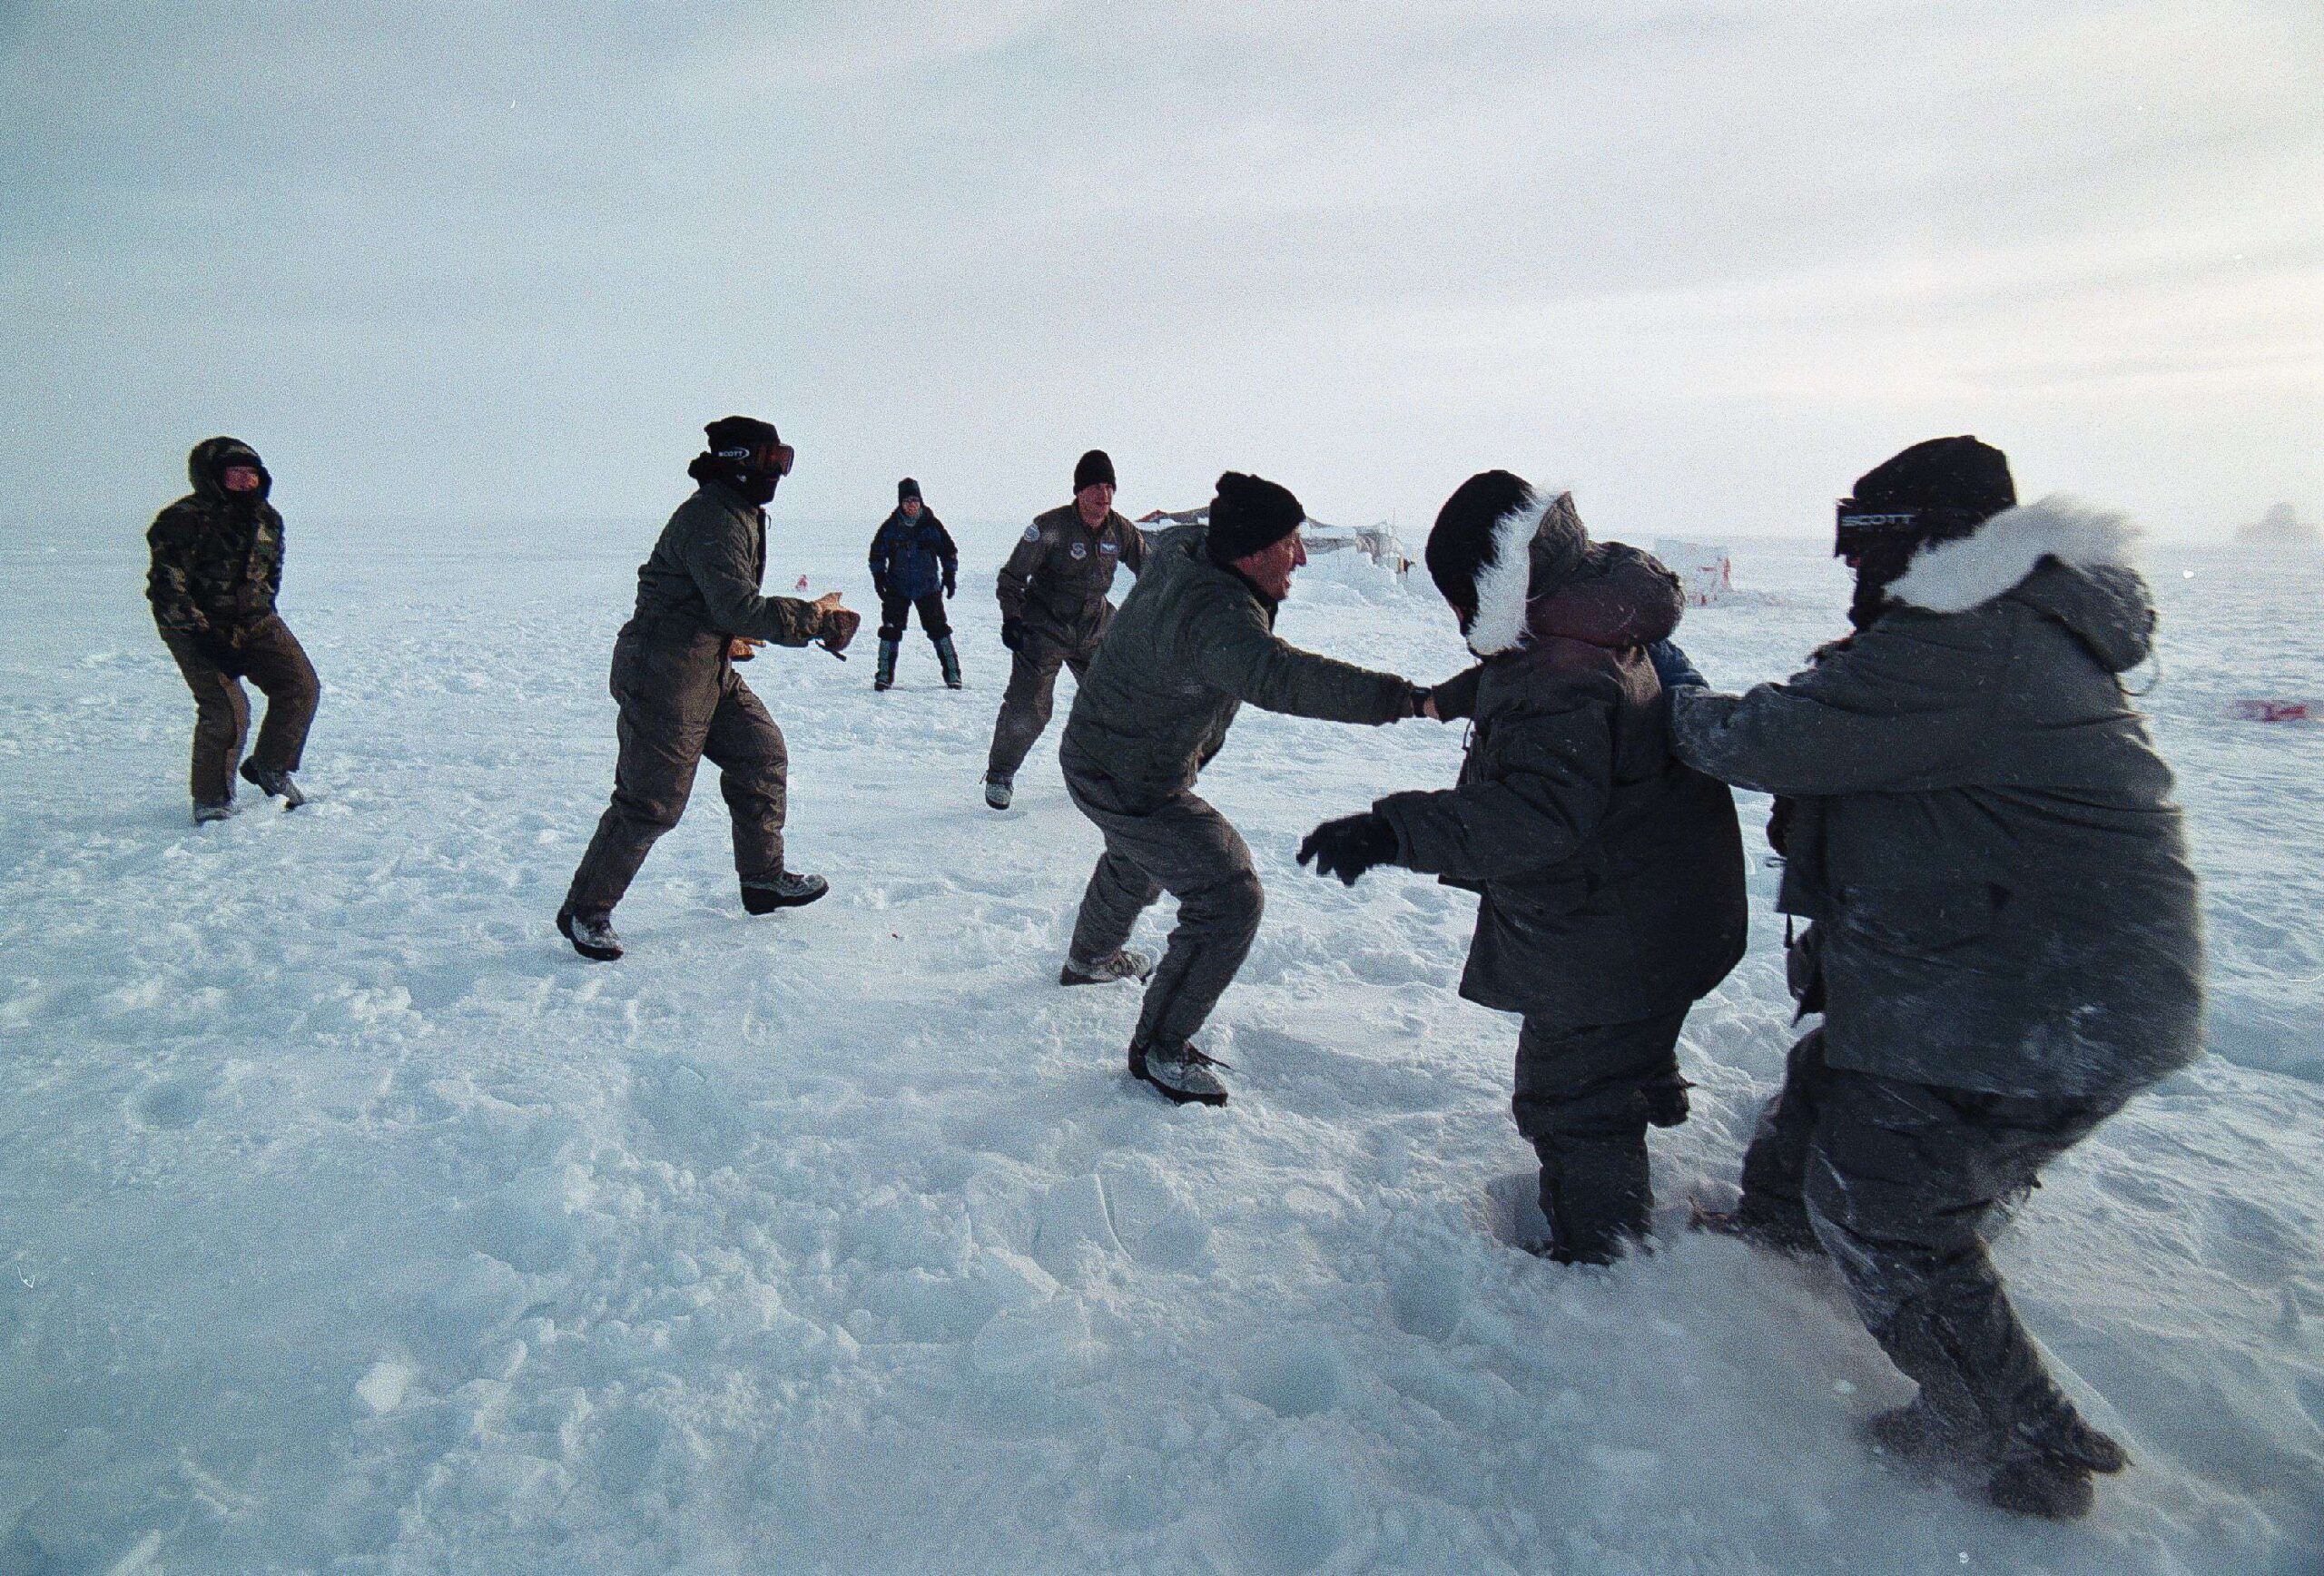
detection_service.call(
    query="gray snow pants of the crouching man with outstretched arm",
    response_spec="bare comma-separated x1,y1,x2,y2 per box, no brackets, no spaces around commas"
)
1062,751,1266,1046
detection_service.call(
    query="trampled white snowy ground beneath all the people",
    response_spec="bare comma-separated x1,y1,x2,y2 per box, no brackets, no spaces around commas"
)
0,509,2324,1576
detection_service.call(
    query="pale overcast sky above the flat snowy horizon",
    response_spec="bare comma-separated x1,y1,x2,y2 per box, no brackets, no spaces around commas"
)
0,0,2324,539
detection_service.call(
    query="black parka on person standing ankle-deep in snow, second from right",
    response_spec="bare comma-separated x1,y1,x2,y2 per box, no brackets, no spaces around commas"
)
1371,542,1746,1028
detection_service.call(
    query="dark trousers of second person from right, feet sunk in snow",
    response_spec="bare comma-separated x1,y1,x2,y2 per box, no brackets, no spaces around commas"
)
1508,1007,1688,1265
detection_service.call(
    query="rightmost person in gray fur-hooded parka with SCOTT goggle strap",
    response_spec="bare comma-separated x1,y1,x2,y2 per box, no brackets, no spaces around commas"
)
1671,437,2203,1518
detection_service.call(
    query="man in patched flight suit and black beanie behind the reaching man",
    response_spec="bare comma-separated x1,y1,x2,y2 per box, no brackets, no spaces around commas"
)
985,448,1148,809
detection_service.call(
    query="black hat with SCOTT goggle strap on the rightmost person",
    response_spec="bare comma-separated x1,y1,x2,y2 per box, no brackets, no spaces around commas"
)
1831,435,2017,630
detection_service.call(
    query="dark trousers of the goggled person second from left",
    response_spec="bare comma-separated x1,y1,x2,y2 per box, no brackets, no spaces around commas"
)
565,627,790,913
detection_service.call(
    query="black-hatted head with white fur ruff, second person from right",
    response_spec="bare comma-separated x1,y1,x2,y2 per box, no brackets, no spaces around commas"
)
1424,469,1590,655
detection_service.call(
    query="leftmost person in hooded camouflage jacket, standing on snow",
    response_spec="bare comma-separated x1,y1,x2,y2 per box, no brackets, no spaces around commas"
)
146,437,323,825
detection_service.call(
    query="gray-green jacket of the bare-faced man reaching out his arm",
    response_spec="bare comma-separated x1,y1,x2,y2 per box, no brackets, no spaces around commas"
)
1064,526,1418,804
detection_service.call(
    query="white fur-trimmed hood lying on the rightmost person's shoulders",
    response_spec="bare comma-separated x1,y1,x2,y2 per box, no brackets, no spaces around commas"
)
1889,493,2154,675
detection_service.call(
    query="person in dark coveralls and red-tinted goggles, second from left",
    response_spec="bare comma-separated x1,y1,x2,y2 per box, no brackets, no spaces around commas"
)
557,416,860,962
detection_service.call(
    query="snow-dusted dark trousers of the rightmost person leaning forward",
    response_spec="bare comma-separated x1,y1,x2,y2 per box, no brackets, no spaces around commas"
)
1743,1029,2120,1439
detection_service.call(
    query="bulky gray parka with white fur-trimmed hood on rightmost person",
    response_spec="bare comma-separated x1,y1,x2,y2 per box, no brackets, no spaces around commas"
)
1673,497,2203,1102
